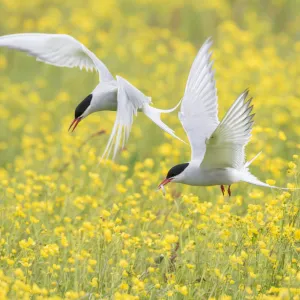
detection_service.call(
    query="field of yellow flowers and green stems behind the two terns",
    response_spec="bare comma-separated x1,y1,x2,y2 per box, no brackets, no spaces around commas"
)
0,0,300,300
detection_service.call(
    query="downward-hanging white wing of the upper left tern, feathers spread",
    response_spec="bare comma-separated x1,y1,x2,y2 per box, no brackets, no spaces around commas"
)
102,76,151,159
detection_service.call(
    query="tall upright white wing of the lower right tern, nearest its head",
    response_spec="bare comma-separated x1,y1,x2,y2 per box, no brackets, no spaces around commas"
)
179,39,219,161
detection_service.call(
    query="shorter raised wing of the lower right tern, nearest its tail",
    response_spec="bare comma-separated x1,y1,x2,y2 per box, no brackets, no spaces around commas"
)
201,91,254,170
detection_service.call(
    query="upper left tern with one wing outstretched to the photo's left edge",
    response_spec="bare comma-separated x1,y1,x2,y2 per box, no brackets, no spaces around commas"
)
0,33,179,158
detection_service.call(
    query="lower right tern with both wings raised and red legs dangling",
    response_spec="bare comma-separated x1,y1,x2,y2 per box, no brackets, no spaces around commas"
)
159,38,294,196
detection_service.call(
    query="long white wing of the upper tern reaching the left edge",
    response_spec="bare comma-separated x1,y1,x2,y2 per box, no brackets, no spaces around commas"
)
0,33,114,81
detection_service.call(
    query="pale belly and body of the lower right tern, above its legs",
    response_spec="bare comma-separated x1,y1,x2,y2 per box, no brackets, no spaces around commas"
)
182,168,241,186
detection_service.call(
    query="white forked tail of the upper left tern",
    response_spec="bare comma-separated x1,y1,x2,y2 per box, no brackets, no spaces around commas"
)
143,101,185,143
